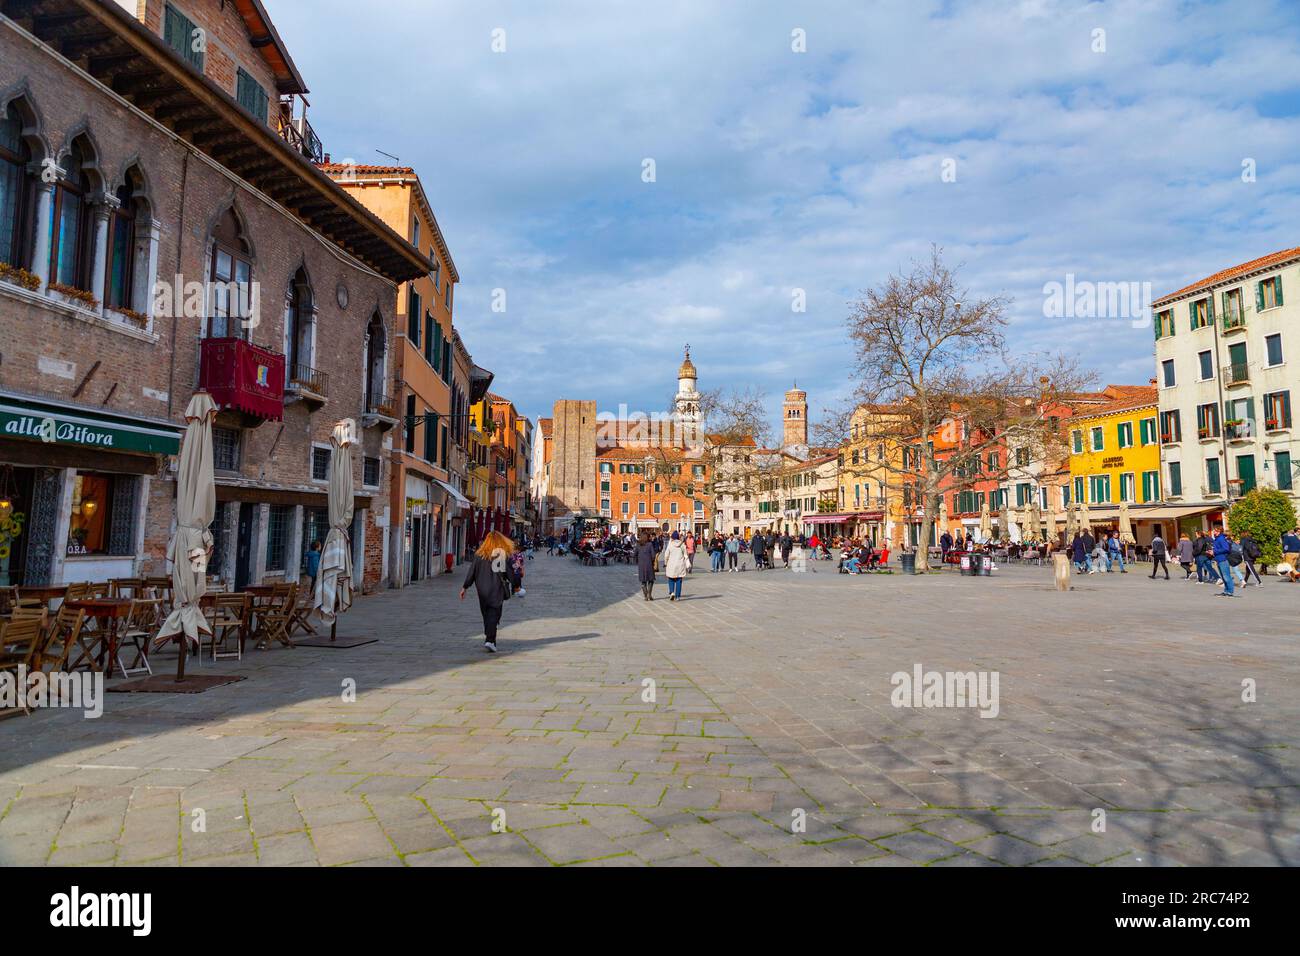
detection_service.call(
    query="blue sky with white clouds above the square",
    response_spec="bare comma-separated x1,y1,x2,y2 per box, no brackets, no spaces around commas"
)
268,0,1300,429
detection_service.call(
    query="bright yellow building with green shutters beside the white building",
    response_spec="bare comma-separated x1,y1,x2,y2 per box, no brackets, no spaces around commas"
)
1069,386,1162,515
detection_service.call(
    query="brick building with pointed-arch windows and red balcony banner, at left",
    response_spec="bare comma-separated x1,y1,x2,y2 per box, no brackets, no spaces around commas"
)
0,0,432,589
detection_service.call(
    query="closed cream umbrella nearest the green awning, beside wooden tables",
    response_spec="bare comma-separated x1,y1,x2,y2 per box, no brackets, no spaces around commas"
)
153,392,217,680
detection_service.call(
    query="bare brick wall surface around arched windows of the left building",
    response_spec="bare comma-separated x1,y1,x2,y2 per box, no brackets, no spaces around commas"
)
0,24,397,580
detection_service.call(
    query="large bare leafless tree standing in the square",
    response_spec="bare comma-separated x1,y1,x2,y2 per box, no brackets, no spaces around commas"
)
823,247,1092,570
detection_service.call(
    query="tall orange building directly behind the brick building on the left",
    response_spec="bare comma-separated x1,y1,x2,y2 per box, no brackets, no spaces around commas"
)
321,157,471,587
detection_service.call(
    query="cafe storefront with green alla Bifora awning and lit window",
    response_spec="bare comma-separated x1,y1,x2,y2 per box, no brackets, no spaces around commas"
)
0,392,182,587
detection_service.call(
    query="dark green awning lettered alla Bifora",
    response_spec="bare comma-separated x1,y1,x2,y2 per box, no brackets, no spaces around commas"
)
0,392,182,455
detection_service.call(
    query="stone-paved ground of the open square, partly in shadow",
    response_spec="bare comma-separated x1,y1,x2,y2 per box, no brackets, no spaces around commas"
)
0,554,1300,866
